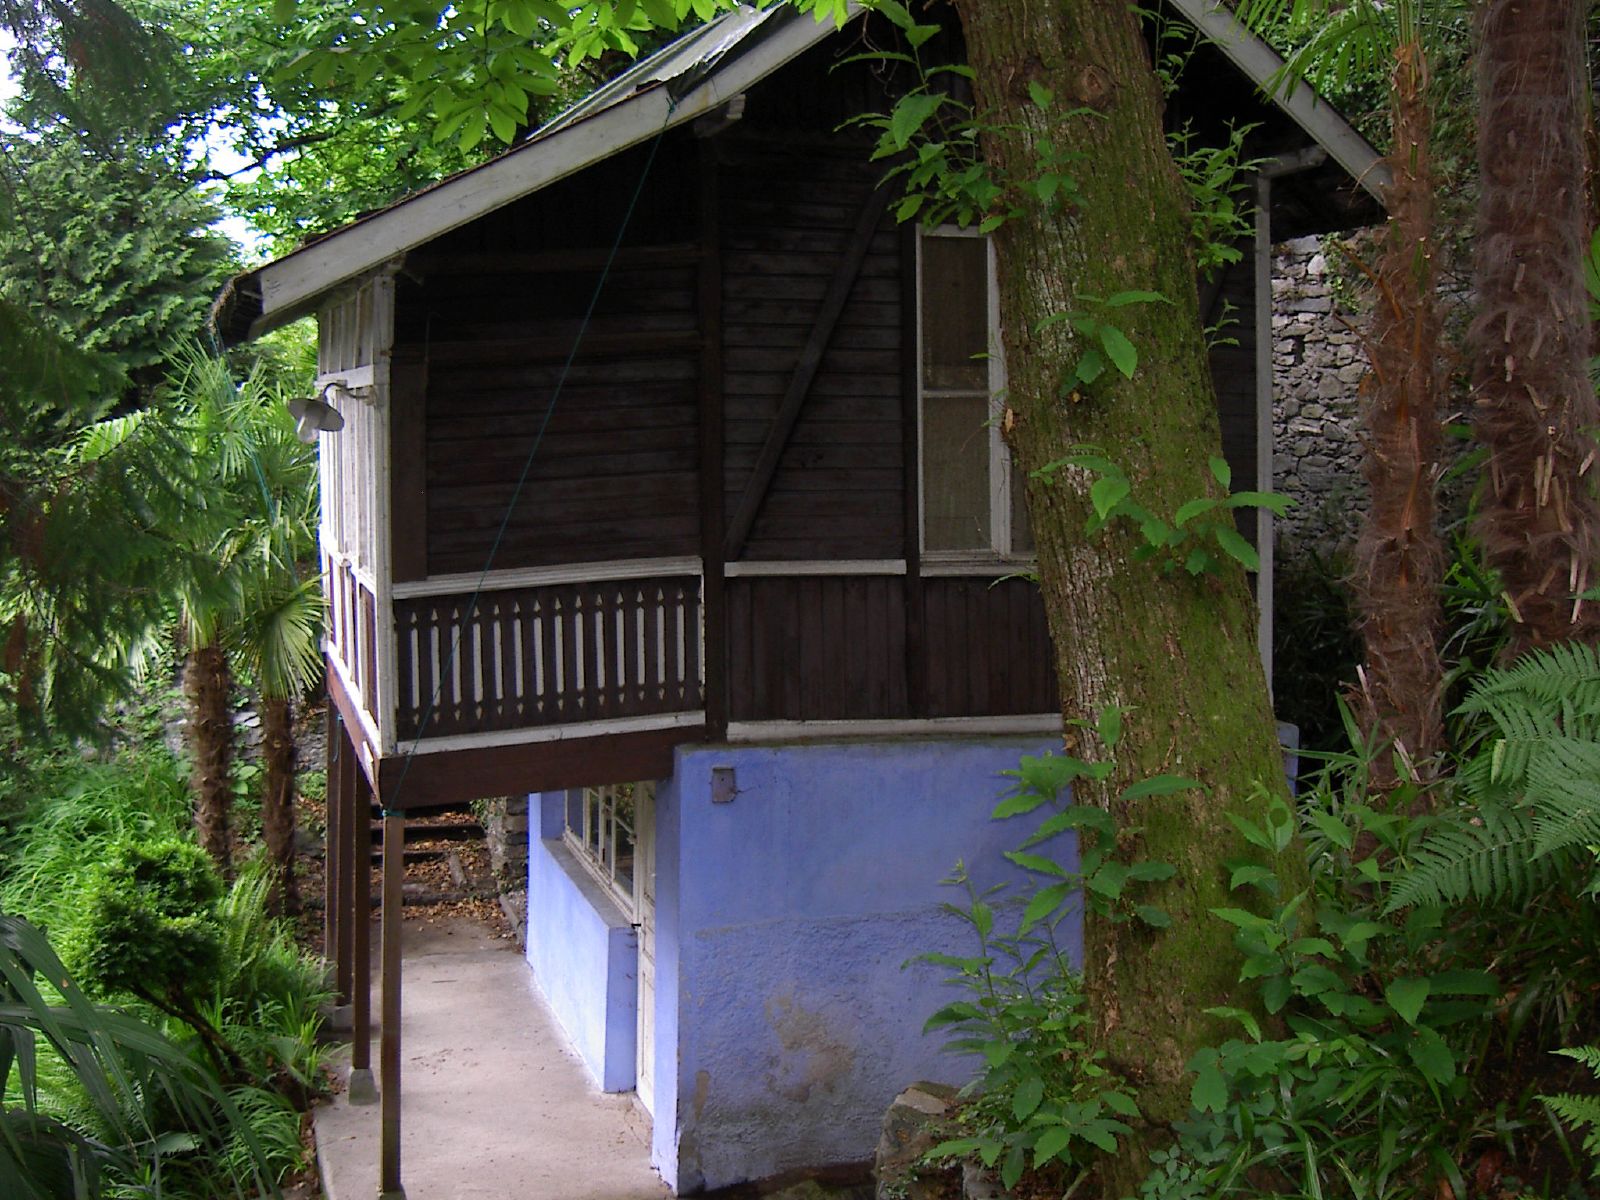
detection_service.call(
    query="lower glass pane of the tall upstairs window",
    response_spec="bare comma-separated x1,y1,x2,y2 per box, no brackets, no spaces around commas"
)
922,395,989,550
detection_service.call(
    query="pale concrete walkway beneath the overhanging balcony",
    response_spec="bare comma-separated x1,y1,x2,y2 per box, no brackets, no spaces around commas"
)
315,920,669,1200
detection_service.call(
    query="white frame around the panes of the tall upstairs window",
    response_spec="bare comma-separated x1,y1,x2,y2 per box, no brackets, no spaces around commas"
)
917,226,1035,568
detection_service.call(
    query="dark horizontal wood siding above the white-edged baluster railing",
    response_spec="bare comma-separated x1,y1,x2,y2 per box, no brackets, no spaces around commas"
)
397,134,699,574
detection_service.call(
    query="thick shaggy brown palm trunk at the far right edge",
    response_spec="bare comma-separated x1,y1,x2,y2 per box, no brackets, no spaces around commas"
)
1470,0,1600,656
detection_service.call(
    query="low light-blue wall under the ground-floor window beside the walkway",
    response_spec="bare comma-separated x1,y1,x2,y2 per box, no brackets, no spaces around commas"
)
528,792,638,1091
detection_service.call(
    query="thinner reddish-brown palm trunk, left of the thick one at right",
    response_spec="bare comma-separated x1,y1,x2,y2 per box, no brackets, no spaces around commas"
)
1354,28,1445,795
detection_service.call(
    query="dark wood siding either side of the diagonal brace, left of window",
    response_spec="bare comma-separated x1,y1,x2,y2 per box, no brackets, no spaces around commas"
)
718,136,906,562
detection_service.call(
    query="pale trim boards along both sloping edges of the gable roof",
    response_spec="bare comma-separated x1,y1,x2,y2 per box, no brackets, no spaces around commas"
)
236,0,1389,338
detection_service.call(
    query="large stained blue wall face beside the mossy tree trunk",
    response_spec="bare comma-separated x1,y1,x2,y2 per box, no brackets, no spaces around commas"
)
651,738,1080,1192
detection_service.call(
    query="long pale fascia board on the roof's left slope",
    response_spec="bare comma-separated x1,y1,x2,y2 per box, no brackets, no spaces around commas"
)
250,5,861,338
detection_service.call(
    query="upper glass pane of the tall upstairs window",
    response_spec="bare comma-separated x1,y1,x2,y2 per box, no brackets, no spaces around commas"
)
922,237,989,389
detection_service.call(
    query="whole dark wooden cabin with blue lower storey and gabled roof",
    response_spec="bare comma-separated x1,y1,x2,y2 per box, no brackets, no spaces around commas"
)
224,0,1376,1190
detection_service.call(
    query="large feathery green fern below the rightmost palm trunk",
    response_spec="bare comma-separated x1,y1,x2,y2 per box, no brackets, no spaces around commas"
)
1390,643,1600,910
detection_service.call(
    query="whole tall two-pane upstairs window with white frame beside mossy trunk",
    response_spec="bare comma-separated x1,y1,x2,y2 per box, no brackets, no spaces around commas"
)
917,229,1034,558
